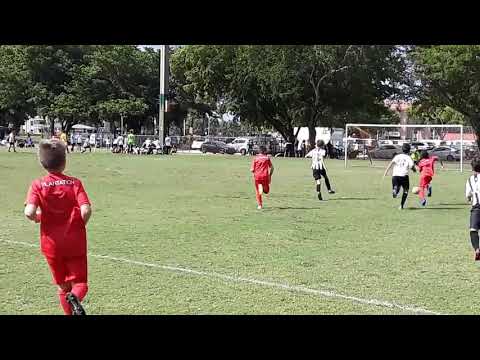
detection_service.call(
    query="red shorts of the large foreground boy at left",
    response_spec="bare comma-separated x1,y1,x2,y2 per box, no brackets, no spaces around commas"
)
46,256,88,285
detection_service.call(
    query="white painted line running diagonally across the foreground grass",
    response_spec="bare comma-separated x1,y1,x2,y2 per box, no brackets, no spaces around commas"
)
0,239,442,315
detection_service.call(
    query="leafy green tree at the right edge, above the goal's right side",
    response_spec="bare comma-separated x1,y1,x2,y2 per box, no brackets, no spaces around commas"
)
409,45,480,146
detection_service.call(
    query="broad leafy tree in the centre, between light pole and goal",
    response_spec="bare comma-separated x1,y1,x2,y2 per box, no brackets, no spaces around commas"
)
172,45,404,146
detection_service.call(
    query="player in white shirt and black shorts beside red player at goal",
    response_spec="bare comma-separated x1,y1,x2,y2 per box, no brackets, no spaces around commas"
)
383,144,417,209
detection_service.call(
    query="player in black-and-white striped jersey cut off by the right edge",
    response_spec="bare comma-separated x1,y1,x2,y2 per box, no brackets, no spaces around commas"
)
465,157,480,261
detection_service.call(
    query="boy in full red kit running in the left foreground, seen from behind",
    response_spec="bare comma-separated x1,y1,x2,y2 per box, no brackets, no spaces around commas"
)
25,139,92,315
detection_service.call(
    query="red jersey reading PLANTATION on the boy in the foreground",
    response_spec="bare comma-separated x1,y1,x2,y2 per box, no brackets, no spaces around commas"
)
27,173,90,257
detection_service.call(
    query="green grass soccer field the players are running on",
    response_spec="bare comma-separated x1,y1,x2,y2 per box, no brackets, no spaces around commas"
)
0,150,480,314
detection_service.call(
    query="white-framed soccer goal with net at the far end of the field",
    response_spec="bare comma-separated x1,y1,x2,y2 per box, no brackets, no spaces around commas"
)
343,124,466,172
